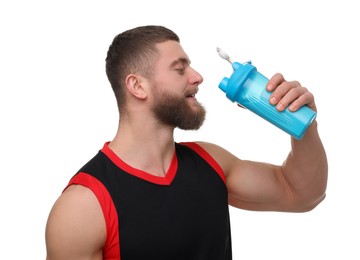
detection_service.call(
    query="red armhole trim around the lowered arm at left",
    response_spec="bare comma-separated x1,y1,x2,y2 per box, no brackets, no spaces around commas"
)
64,172,120,259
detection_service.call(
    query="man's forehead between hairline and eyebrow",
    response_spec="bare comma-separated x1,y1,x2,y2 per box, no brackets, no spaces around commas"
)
156,41,190,66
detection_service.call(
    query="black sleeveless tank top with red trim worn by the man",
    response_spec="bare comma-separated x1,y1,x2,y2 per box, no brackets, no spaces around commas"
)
69,143,232,260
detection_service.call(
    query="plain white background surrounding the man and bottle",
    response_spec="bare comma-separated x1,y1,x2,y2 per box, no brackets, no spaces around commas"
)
0,0,360,260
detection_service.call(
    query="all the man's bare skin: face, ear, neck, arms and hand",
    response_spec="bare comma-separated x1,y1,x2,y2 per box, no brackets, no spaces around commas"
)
46,41,327,260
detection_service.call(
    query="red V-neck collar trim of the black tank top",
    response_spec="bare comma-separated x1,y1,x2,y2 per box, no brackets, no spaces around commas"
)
101,142,178,185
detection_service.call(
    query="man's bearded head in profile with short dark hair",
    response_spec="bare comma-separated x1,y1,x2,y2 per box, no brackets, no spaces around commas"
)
106,26,205,129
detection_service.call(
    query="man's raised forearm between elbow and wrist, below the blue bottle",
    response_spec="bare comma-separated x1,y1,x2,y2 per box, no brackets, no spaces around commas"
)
282,121,328,208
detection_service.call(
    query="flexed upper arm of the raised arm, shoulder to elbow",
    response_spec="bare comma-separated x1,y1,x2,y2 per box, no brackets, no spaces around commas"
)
199,142,293,211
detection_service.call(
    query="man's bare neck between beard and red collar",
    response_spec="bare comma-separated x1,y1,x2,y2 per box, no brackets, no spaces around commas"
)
109,114,175,176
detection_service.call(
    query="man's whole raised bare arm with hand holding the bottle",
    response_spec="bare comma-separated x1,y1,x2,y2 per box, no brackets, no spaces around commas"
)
199,74,328,212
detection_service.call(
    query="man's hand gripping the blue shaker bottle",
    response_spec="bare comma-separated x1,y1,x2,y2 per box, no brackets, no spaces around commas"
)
266,73,317,112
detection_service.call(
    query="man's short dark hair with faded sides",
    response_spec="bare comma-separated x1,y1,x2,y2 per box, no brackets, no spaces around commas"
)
106,25,180,111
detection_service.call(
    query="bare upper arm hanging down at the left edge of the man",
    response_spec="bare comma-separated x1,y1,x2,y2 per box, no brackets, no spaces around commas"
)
46,185,106,260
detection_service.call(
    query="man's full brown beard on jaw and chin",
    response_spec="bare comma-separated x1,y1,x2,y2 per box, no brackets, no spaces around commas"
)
153,86,206,130
